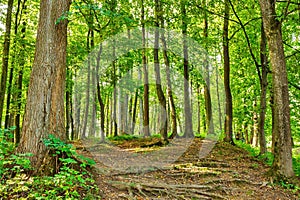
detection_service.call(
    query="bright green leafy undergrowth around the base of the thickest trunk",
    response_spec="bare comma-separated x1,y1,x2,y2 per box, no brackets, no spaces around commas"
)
0,130,100,199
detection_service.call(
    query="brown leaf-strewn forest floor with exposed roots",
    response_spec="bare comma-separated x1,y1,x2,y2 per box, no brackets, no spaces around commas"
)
74,138,300,200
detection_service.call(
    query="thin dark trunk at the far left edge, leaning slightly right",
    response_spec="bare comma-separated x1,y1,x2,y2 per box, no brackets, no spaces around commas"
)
0,0,14,127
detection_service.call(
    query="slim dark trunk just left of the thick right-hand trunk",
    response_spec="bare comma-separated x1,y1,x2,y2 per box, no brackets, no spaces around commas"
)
258,24,268,154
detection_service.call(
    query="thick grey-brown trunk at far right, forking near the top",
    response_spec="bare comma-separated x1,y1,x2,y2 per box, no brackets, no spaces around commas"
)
259,0,294,177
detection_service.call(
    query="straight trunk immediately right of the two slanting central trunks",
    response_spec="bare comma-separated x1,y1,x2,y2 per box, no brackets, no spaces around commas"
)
180,0,194,137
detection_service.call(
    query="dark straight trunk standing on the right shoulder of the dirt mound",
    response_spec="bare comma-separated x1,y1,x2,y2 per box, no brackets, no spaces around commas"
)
223,0,234,144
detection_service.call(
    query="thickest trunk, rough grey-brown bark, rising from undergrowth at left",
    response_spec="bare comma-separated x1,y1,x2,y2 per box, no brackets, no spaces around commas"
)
17,0,71,171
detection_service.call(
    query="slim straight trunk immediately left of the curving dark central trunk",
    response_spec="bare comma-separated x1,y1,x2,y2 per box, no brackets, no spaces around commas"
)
141,0,150,137
